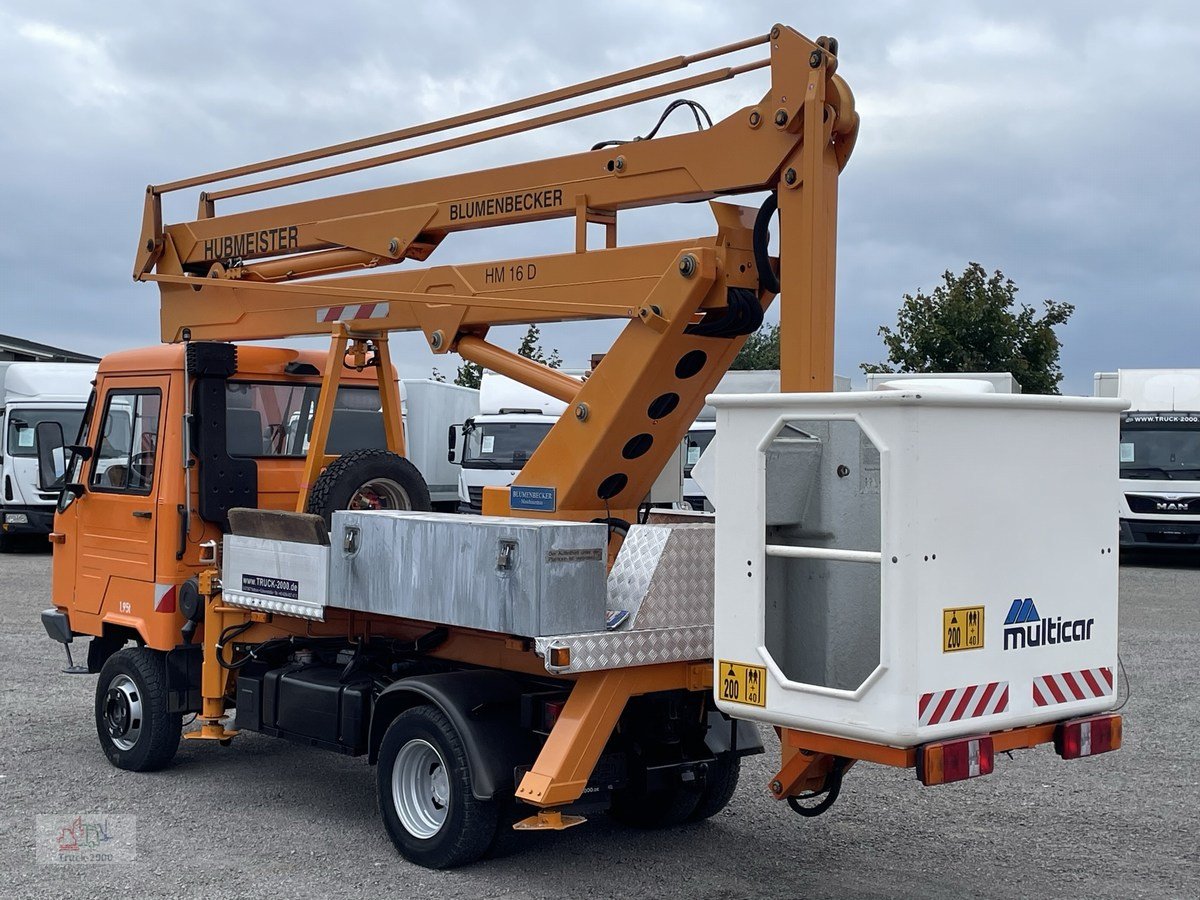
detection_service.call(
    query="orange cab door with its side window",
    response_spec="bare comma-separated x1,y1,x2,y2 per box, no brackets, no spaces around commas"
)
72,376,169,618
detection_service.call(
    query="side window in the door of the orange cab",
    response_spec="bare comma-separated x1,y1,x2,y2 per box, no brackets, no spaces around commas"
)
89,388,162,494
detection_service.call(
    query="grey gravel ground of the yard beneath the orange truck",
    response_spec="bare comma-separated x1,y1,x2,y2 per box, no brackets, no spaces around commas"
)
0,548,1200,899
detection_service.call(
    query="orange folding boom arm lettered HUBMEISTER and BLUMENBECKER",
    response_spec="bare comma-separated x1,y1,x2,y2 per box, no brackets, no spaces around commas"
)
134,25,858,521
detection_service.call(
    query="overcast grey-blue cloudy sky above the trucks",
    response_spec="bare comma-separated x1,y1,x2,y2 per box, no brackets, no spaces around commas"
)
0,0,1200,392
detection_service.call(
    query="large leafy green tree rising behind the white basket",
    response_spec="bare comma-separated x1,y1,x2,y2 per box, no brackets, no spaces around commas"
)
862,263,1075,394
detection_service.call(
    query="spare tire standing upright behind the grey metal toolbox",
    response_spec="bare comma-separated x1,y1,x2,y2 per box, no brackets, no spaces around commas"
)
305,449,433,527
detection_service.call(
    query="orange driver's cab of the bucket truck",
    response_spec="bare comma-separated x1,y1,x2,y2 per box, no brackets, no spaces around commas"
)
39,344,384,657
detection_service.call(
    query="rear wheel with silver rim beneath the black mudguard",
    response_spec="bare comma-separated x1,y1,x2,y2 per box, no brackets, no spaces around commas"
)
376,706,500,869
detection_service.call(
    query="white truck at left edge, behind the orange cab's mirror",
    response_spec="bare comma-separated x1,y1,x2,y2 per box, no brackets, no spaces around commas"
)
0,362,96,550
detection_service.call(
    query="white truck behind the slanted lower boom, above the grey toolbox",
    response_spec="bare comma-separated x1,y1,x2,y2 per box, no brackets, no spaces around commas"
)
451,372,683,515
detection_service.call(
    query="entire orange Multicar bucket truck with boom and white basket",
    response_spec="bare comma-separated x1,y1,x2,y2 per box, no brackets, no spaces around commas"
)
36,25,1123,868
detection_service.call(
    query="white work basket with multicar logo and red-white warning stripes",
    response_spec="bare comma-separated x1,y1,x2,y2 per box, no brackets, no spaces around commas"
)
708,391,1124,746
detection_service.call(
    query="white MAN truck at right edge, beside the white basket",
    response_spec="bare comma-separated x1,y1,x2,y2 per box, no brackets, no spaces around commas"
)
1092,368,1200,551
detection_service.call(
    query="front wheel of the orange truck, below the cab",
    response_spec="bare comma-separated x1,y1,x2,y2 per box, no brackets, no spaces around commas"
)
96,647,184,772
